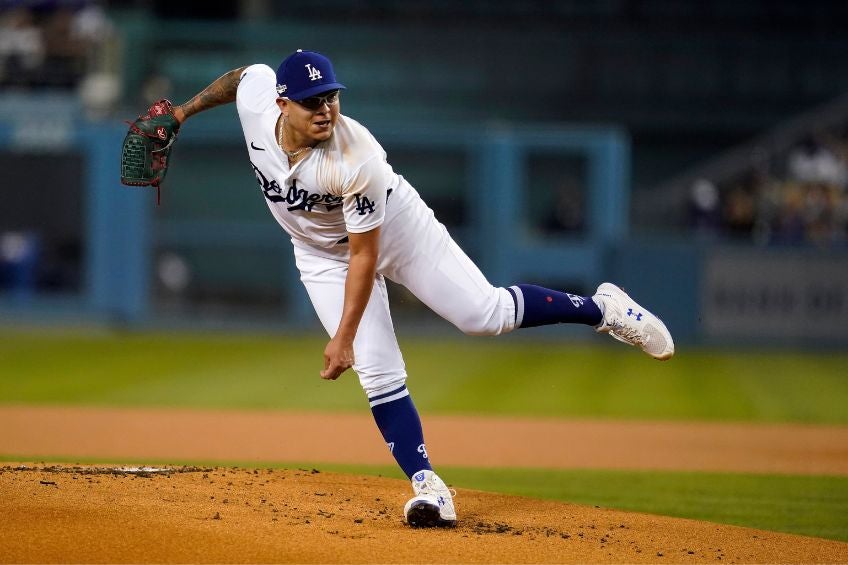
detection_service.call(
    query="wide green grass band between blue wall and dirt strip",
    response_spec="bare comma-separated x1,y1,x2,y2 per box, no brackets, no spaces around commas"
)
0,331,848,424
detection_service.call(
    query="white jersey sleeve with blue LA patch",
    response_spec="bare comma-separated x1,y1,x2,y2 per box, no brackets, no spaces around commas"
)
342,155,393,233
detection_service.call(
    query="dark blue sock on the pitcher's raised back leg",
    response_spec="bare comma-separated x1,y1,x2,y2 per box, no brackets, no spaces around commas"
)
507,284,603,328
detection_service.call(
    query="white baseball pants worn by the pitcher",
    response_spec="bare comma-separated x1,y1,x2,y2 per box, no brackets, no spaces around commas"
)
293,181,515,397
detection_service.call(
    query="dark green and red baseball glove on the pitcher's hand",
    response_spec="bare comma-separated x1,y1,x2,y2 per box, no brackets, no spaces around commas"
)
121,100,180,197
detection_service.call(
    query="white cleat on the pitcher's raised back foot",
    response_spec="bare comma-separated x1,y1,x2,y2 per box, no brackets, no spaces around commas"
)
592,283,674,361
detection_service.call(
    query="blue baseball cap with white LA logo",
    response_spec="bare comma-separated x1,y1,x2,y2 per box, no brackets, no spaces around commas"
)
277,49,345,100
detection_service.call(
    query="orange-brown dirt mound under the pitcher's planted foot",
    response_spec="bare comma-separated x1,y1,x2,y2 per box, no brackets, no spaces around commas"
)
0,465,848,563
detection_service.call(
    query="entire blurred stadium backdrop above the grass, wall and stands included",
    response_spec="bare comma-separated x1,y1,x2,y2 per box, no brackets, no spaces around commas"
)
0,0,848,347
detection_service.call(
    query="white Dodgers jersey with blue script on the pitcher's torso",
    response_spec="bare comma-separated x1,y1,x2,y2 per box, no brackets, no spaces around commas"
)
236,65,410,247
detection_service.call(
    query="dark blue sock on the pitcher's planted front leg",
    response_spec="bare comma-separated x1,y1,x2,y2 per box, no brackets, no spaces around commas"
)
368,385,433,479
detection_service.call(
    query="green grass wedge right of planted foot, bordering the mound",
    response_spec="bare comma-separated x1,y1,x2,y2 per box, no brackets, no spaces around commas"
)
440,462,848,541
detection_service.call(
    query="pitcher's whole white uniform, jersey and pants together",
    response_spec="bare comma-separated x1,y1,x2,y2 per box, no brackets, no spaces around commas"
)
236,65,516,396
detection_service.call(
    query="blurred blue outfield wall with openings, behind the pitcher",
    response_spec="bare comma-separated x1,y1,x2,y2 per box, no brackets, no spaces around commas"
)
0,116,848,345
